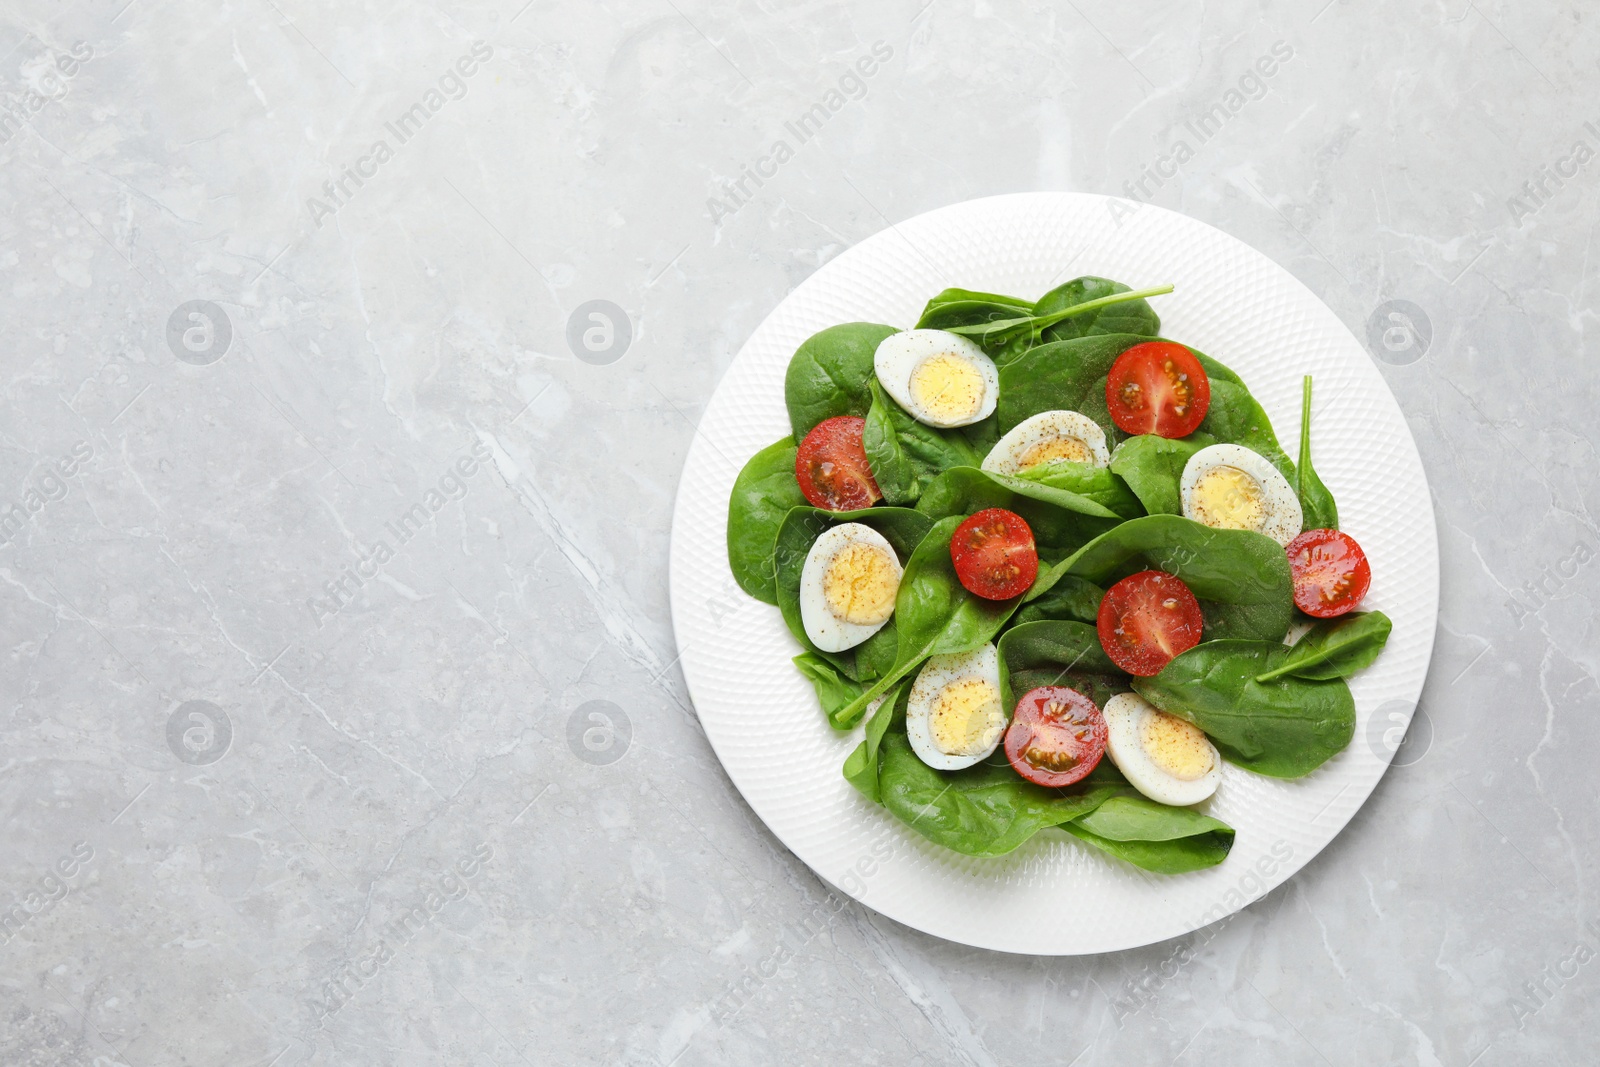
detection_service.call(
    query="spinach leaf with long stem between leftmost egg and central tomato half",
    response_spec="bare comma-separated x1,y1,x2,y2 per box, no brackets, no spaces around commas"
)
832,515,1021,729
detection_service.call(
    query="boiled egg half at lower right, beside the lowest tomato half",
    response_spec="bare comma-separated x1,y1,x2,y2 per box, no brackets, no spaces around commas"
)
1102,693,1222,806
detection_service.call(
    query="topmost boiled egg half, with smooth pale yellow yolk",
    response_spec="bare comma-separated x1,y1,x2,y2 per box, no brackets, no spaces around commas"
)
872,330,1000,429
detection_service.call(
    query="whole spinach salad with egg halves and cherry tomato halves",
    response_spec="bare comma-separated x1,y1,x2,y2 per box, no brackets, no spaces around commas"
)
728,277,1390,873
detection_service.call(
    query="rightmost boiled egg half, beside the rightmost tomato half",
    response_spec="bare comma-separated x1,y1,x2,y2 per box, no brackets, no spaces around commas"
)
1178,445,1304,545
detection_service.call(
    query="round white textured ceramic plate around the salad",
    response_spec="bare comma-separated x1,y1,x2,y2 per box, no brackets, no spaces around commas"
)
672,194,1438,955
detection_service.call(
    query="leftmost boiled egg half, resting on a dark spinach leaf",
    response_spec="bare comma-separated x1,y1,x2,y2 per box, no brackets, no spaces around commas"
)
800,523,902,653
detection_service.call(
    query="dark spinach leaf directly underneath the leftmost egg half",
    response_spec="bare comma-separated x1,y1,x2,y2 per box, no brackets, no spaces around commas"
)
773,507,949,683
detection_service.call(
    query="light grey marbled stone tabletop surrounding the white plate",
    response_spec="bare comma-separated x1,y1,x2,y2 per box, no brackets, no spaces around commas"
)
0,0,1600,1067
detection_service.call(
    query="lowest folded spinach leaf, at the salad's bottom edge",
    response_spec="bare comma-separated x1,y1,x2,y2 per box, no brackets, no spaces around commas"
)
1062,795,1234,875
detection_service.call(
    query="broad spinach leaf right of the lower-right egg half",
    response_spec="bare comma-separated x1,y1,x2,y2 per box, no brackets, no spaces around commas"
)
1133,640,1355,777
